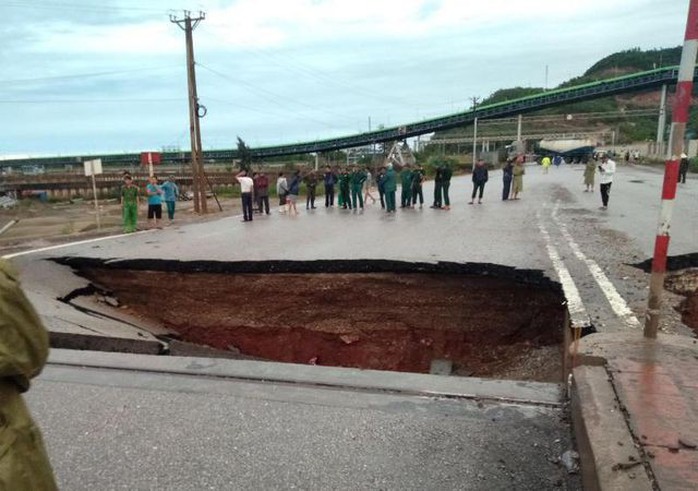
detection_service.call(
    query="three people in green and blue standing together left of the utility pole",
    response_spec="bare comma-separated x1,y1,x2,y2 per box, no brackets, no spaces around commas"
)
120,172,179,234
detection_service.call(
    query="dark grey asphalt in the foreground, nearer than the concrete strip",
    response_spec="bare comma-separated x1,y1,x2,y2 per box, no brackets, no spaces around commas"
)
28,365,580,490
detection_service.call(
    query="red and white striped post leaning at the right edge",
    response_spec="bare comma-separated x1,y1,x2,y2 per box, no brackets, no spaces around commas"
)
644,0,698,339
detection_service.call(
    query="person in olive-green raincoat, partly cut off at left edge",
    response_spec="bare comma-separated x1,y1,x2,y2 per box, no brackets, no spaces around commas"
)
0,259,58,491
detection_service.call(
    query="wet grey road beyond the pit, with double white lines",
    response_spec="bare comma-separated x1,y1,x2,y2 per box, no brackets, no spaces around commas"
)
8,161,698,338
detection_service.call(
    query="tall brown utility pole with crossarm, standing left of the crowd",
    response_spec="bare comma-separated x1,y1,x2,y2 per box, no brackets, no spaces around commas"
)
170,10,208,213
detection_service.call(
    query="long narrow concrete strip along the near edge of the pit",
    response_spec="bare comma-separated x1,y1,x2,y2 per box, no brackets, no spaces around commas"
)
49,349,562,407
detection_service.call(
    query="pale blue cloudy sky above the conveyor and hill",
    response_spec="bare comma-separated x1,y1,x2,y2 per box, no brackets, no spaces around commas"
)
0,0,688,158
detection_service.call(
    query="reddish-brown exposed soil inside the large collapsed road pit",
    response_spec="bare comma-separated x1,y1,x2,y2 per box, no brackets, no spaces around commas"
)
81,267,565,382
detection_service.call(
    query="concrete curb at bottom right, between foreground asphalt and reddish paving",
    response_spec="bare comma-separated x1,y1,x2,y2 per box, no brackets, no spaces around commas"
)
570,366,654,491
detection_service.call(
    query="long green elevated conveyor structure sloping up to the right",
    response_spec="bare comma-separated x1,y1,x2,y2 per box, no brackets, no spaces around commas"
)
0,66,698,167
